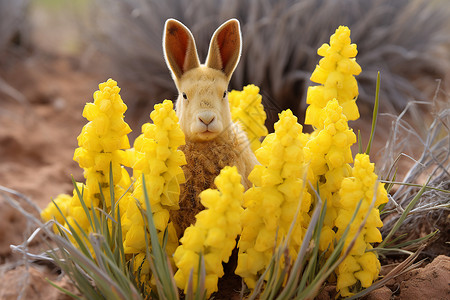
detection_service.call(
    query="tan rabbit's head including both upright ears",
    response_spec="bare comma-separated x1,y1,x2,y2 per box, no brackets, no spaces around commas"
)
163,19,241,141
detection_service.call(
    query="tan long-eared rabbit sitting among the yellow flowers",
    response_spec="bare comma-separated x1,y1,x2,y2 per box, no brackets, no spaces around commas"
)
163,19,258,236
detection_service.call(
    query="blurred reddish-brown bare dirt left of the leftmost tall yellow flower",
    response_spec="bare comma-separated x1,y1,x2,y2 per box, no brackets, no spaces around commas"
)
0,57,101,208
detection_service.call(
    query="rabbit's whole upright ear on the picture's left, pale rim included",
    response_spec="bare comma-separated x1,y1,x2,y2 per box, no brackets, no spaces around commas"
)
163,19,200,79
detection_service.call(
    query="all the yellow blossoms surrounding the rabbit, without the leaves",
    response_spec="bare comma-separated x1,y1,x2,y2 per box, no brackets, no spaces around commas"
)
41,26,387,297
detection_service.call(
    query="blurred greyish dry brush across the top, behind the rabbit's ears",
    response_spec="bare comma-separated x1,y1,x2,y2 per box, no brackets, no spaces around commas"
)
0,0,450,126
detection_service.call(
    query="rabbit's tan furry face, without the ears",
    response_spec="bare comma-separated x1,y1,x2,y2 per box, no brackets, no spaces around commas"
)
176,66,231,141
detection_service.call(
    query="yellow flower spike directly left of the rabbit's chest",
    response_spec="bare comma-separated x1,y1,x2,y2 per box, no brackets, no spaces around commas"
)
120,100,186,282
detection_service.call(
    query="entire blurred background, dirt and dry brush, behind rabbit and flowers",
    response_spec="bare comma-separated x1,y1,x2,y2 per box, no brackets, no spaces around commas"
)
0,0,450,203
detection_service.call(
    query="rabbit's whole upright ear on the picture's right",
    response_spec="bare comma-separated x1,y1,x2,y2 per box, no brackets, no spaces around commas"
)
206,19,242,79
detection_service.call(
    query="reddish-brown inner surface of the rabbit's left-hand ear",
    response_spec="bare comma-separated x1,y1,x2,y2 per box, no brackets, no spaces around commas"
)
166,24,189,72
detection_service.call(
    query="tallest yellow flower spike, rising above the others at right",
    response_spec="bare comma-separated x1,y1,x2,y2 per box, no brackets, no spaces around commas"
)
305,26,361,127
